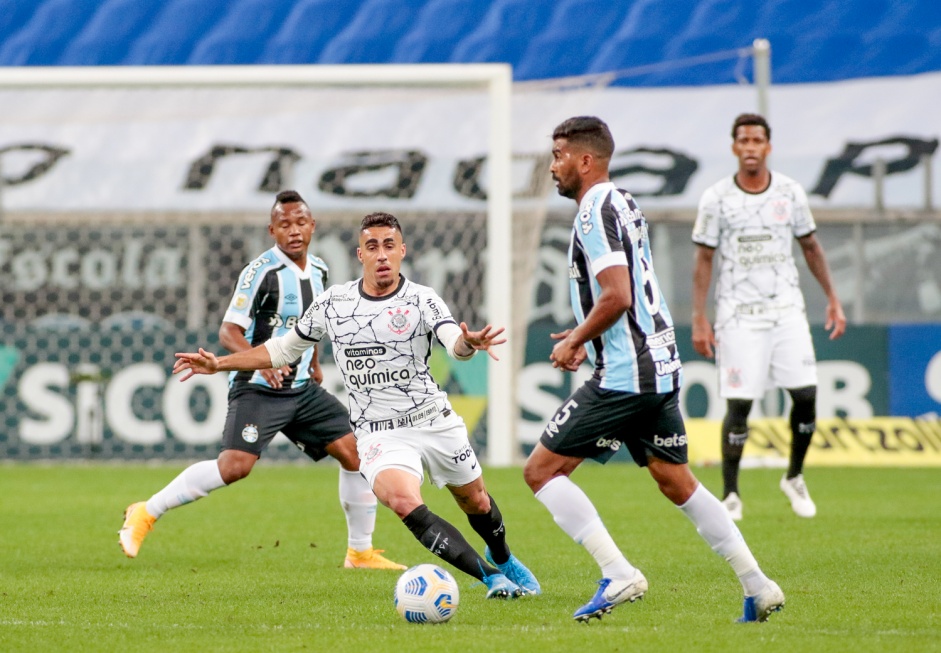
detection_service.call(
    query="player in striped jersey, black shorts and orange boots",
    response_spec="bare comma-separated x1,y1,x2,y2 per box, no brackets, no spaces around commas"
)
119,190,405,569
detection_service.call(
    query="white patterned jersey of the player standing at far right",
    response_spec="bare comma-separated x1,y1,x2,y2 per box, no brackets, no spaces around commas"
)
693,172,817,328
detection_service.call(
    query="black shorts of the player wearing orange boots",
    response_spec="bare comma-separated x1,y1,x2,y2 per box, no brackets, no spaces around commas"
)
222,381,353,460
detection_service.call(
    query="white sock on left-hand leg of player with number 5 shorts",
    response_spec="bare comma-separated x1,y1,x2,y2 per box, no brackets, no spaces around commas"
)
536,476,635,580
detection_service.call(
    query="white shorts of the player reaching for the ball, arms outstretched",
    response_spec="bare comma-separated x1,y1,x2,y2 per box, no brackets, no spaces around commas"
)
356,412,482,488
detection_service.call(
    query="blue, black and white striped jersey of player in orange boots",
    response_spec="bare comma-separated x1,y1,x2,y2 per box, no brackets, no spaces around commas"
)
222,246,327,392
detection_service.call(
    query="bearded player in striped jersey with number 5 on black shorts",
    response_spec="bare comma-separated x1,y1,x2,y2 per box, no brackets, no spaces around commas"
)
523,116,784,621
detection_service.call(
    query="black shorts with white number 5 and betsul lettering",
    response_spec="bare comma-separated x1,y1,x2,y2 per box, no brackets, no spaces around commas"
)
539,379,689,467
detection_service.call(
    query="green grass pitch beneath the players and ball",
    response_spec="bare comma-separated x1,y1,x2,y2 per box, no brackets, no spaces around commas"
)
0,464,941,653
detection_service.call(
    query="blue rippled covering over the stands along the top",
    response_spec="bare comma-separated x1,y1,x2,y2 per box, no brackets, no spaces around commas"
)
0,0,941,85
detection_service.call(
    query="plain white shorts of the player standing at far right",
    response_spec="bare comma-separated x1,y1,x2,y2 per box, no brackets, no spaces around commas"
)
716,314,817,400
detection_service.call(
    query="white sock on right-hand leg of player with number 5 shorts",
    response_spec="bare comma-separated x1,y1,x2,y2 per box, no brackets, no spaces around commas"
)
679,484,768,596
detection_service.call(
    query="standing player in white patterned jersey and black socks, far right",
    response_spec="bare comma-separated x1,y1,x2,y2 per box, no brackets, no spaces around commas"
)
693,114,846,520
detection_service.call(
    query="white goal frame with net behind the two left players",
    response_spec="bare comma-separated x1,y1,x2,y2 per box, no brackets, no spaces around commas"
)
0,65,520,465
